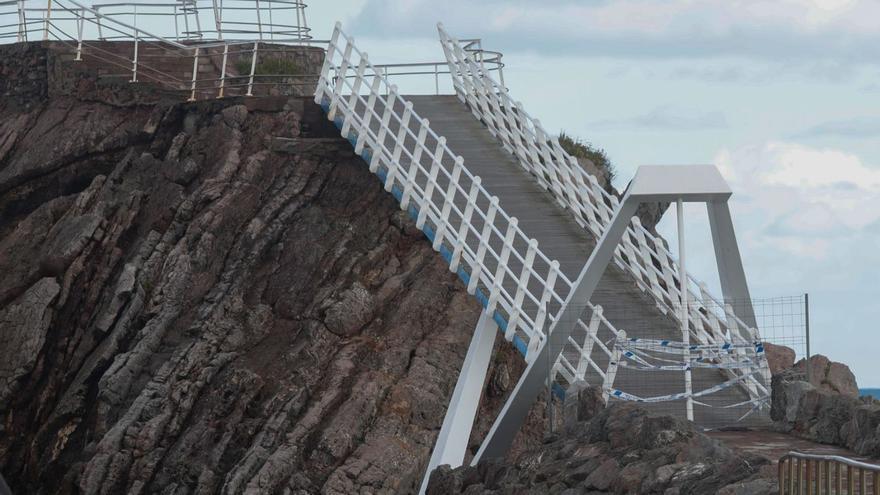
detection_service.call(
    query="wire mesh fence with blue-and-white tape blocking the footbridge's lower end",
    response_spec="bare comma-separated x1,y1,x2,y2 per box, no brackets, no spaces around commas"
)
548,294,809,429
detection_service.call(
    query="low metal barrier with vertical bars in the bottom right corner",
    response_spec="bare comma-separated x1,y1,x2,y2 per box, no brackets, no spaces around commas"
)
779,452,880,495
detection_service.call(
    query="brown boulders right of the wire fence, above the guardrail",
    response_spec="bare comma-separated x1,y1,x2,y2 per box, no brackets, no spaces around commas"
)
770,362,880,458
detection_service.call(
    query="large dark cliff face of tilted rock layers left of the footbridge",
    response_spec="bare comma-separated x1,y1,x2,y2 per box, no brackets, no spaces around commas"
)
0,45,543,494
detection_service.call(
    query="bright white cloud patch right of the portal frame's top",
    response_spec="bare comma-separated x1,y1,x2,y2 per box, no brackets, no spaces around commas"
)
715,142,880,260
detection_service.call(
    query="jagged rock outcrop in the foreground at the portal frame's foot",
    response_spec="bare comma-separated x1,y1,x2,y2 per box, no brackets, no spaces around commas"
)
428,402,778,495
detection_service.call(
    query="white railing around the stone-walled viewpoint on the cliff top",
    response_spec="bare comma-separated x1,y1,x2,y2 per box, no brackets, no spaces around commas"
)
0,0,504,100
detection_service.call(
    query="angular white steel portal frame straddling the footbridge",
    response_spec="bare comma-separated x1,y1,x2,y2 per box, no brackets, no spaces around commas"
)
472,166,766,465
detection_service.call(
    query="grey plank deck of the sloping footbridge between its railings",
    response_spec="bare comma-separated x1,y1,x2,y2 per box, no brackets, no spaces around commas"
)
403,95,768,427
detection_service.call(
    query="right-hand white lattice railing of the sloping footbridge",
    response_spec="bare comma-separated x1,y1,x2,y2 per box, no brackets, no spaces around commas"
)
438,25,770,404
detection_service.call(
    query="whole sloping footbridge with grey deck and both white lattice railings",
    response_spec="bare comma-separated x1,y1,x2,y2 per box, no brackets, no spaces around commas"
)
315,24,769,436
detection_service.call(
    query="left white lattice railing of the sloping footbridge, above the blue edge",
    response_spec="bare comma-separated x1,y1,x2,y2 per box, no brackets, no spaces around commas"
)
315,24,767,405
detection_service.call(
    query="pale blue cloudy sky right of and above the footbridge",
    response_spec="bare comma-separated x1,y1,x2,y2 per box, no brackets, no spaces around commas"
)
309,0,880,387
